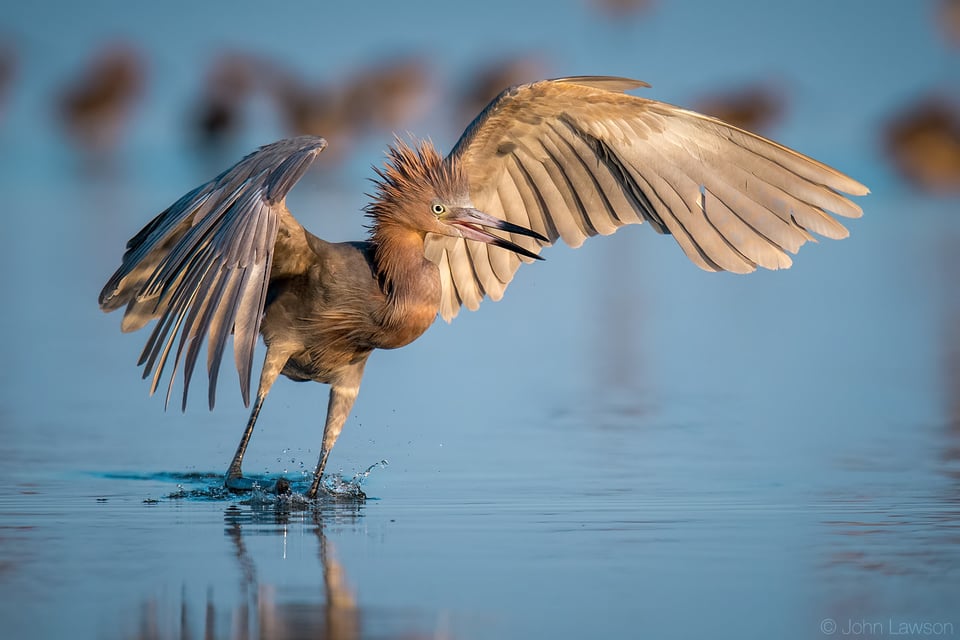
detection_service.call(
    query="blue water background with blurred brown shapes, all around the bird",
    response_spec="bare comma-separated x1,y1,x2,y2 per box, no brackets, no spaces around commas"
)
0,0,960,638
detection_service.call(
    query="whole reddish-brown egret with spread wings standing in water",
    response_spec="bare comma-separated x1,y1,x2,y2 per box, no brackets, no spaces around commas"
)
99,76,869,499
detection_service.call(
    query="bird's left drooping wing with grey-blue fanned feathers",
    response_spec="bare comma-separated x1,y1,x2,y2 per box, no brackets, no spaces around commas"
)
100,136,327,409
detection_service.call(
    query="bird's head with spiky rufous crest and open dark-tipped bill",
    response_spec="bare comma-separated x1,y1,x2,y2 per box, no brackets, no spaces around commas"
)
367,140,549,260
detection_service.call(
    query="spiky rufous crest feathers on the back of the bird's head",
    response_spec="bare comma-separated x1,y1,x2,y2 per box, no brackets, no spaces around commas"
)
365,138,466,227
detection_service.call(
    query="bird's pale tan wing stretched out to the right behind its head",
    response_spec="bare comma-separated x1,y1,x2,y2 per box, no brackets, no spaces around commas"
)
426,77,868,321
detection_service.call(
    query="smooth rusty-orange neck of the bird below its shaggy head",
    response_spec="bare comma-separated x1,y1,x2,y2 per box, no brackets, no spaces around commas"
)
370,221,440,330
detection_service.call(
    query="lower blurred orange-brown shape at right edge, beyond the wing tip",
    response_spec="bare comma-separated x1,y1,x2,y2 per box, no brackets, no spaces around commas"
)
884,95,960,195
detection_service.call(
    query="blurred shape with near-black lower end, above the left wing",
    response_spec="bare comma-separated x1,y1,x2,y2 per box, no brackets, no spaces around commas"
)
191,53,259,147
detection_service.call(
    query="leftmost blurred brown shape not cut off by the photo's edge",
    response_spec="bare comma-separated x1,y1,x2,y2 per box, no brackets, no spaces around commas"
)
58,44,146,154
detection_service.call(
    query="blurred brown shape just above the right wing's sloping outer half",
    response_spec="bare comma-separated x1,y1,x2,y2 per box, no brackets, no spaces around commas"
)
694,82,787,133
